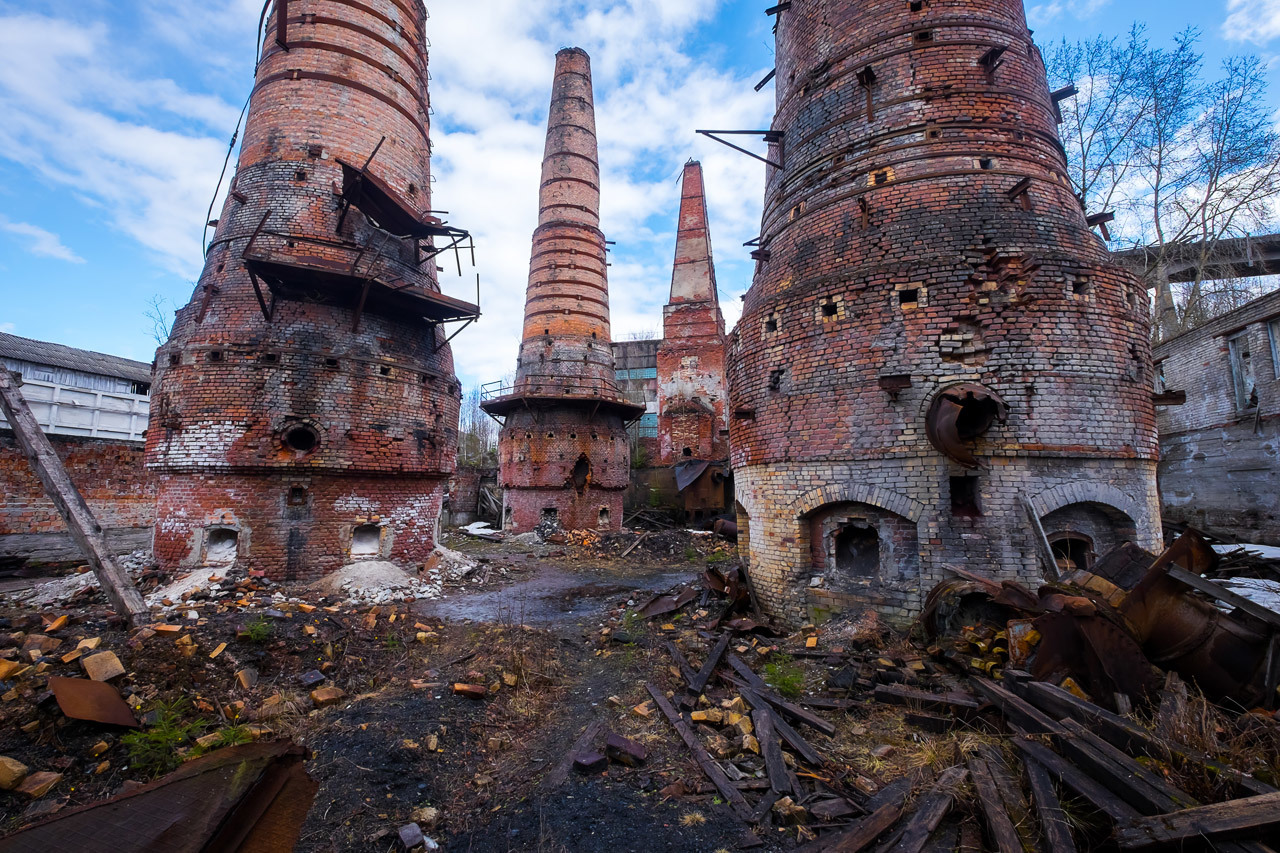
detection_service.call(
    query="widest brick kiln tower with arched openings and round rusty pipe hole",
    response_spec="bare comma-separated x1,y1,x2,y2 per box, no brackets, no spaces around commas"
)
730,0,1160,620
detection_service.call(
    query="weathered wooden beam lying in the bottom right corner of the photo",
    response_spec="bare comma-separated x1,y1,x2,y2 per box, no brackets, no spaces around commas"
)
1115,794,1280,850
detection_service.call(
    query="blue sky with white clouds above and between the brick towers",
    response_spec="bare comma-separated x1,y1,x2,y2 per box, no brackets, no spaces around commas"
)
0,0,1280,384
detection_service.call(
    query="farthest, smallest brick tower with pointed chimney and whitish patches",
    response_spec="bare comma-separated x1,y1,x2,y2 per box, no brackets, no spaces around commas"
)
658,160,728,519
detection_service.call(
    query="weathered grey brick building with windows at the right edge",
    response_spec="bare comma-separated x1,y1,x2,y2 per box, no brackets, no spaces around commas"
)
1155,291,1280,546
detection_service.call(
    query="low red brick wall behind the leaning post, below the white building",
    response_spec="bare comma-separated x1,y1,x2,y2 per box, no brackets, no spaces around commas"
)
0,430,156,565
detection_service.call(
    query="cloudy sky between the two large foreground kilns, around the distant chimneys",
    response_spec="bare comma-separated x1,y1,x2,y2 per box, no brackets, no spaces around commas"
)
429,0,773,384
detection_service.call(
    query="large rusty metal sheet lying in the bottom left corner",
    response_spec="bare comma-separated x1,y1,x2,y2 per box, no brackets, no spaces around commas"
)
0,742,319,853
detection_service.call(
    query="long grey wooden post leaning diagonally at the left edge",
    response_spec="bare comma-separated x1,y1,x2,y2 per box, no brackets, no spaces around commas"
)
0,366,150,625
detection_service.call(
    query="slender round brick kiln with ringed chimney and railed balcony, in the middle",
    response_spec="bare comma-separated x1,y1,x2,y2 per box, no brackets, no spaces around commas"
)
481,47,644,530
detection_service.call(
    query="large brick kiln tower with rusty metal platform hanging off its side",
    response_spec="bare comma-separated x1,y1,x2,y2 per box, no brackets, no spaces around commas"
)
147,0,477,580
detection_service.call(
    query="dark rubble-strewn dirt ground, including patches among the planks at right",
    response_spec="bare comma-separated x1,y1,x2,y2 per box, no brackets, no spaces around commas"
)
0,532,1280,853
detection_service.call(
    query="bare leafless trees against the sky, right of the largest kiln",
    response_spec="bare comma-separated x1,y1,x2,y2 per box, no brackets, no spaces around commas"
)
1046,27,1280,337
